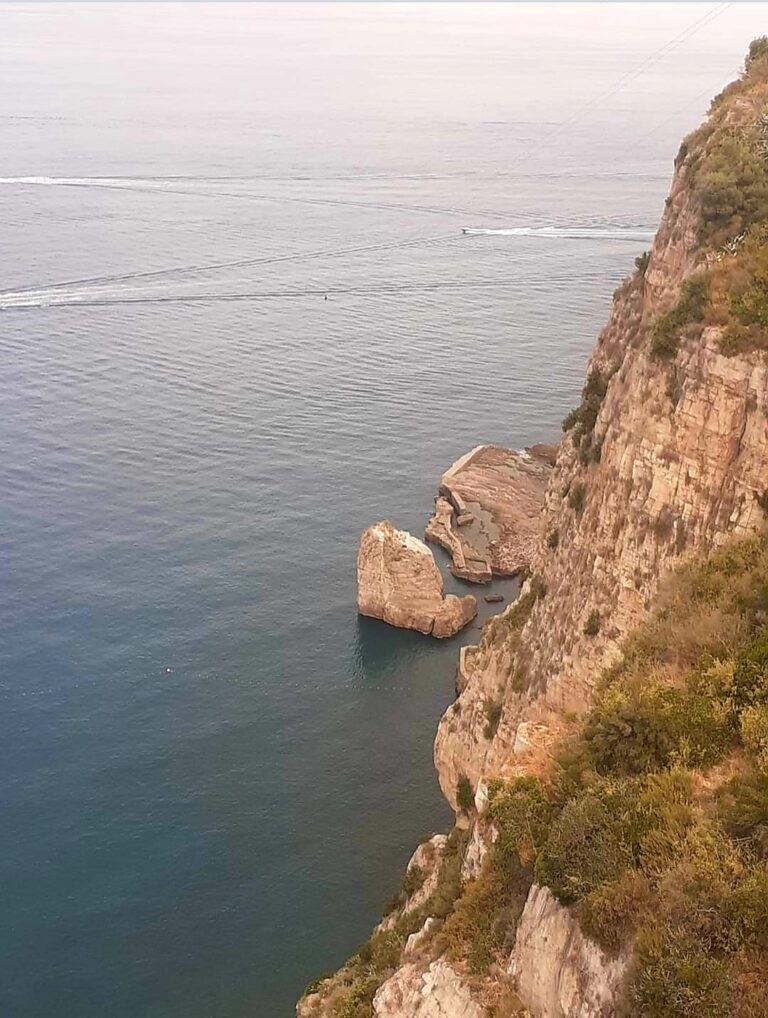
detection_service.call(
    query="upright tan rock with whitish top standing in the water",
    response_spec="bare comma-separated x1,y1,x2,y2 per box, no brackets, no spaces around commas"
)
358,520,478,638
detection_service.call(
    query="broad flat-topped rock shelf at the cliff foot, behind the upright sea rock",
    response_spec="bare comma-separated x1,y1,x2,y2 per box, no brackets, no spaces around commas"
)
426,446,551,583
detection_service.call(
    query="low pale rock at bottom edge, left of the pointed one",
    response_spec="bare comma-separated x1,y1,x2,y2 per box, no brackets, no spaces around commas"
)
373,958,488,1018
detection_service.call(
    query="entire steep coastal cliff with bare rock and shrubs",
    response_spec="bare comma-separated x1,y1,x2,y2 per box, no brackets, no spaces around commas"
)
297,40,768,1018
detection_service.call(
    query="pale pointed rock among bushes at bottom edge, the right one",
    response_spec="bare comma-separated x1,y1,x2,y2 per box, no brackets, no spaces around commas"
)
508,885,627,1018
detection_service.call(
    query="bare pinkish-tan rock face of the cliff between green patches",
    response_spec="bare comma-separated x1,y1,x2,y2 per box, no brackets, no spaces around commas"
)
435,91,768,803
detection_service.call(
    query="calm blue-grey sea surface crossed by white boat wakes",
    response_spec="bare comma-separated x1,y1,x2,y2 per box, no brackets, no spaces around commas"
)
0,4,768,1018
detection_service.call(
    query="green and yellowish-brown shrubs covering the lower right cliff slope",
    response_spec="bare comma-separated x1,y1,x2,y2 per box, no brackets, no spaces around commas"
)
444,536,768,1018
